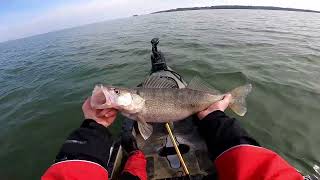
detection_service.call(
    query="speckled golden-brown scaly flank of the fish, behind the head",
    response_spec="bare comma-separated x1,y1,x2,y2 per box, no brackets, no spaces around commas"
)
137,88,223,122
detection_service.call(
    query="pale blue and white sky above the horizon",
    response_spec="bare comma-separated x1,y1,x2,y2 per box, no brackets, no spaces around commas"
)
0,0,320,42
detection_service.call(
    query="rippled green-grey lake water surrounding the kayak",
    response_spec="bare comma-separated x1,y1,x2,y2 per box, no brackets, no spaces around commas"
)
0,10,320,180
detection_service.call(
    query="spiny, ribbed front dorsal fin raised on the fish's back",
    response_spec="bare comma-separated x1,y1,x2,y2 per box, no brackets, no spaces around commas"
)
142,76,177,88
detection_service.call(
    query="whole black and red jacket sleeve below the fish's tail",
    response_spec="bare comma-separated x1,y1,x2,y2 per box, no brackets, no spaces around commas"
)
198,111,303,180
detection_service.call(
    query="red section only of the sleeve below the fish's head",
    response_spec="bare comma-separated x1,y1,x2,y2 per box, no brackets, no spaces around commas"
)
41,160,108,180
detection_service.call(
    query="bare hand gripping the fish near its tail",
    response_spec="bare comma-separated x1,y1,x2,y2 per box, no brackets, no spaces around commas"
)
197,94,232,120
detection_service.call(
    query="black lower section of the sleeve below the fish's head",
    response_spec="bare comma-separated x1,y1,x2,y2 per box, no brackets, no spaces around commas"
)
56,119,112,167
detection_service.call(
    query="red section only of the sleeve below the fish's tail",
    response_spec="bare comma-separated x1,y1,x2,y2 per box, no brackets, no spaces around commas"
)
215,145,303,180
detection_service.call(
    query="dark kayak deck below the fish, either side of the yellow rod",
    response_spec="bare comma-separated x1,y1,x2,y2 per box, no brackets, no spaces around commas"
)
137,118,214,179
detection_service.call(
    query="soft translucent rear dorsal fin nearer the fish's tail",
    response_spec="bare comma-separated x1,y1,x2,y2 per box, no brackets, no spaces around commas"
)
187,76,221,94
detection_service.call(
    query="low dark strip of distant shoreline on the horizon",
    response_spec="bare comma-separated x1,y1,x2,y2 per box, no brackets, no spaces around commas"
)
151,5,320,14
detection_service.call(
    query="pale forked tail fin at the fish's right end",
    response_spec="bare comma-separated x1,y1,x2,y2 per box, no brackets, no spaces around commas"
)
229,84,252,116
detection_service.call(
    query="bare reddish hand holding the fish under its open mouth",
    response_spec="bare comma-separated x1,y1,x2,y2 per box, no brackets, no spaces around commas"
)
82,98,117,127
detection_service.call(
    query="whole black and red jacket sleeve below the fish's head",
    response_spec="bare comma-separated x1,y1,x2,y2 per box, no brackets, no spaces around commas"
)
42,120,112,180
